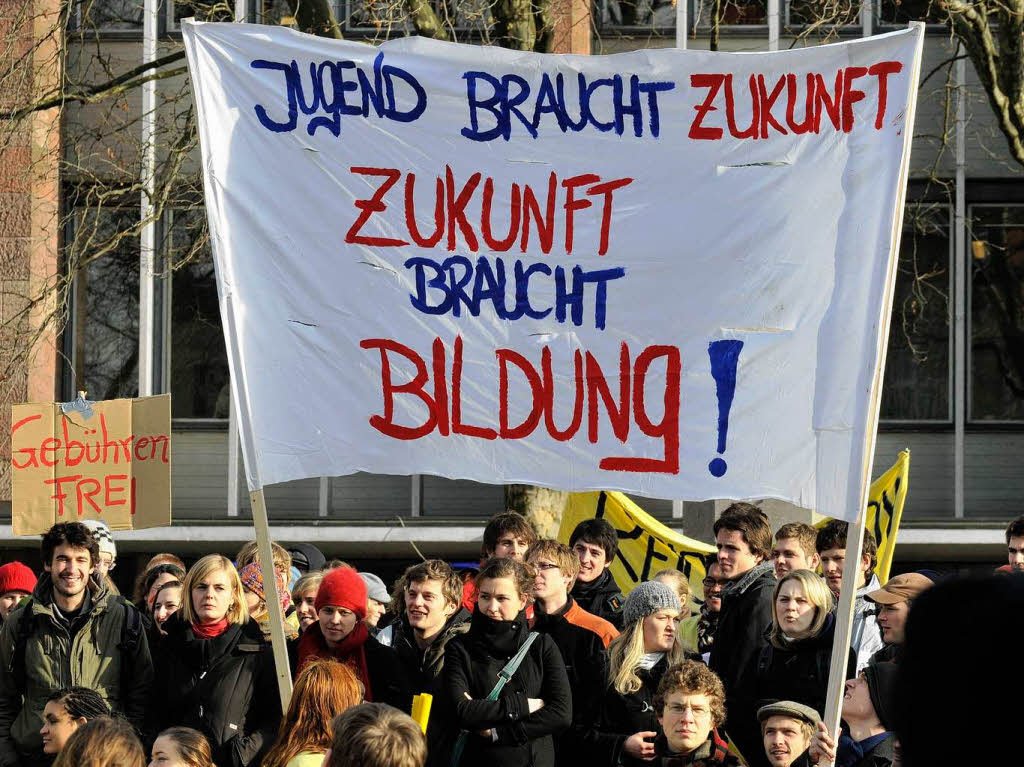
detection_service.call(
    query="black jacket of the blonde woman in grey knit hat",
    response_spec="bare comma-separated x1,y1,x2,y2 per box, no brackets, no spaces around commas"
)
589,654,669,767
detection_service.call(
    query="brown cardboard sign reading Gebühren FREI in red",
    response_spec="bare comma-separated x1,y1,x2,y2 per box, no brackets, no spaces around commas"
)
11,394,171,536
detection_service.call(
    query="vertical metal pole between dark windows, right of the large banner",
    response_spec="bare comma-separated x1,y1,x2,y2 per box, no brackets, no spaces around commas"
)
953,52,971,519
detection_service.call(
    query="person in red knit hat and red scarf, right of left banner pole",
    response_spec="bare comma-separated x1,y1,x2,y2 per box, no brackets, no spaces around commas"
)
299,567,413,713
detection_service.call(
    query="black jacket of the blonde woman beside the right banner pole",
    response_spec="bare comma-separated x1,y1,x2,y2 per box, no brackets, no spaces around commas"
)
757,613,857,717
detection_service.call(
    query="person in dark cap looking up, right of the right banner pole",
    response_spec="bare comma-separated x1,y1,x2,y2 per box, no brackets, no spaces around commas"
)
808,664,898,767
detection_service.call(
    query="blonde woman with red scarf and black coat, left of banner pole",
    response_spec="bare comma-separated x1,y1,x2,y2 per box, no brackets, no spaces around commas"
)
148,554,281,767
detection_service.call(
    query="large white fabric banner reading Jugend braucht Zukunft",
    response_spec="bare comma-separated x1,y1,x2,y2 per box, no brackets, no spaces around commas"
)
183,23,922,518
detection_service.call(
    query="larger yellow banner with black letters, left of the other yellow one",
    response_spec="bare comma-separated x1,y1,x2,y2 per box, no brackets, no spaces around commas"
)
558,491,715,600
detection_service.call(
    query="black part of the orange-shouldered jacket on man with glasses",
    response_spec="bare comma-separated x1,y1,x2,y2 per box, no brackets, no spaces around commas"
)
534,597,608,765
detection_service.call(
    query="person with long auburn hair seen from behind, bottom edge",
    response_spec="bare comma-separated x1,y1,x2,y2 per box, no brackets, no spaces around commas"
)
262,659,362,767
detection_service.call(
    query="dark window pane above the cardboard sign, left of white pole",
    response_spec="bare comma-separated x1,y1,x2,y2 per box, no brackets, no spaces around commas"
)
67,208,139,399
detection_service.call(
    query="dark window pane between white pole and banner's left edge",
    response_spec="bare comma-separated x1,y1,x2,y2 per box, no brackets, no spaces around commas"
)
166,209,228,418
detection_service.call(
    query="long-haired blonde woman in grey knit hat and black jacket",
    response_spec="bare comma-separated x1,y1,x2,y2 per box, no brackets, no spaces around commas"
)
595,581,686,767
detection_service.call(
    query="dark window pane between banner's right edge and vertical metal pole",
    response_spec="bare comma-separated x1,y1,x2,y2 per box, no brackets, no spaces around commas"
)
882,205,950,421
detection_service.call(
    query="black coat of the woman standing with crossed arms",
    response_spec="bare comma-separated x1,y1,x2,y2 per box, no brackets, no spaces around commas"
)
432,610,572,767
